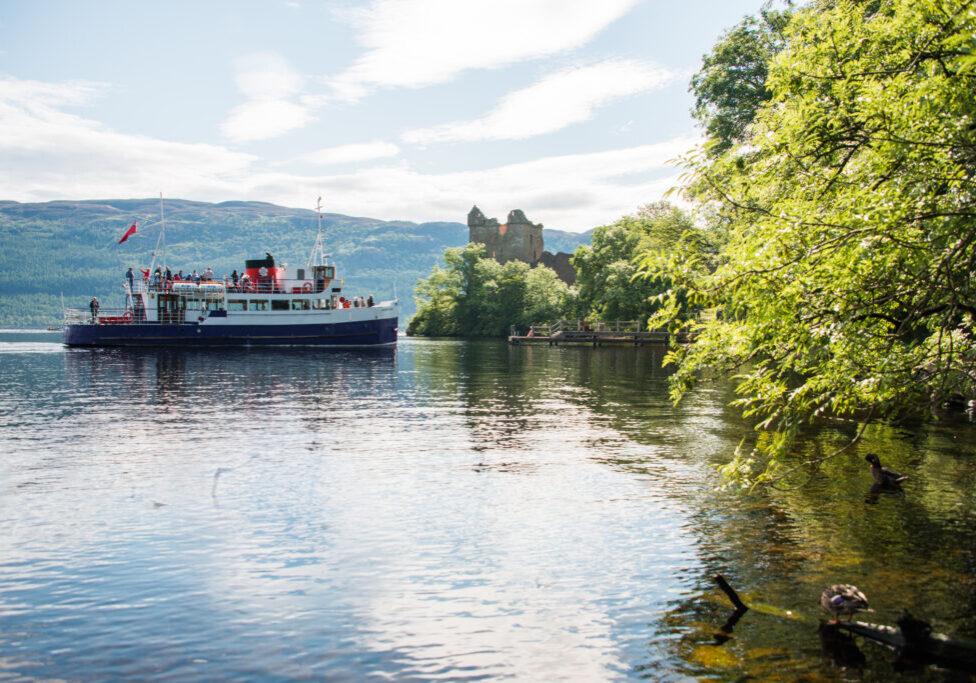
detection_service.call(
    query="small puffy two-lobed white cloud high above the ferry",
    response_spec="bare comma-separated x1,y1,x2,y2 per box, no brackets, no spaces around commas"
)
220,52,312,143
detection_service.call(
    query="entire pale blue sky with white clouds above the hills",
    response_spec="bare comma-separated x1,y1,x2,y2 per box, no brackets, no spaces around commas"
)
0,0,761,231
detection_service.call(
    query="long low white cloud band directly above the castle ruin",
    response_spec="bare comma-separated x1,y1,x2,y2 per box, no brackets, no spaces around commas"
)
243,138,698,231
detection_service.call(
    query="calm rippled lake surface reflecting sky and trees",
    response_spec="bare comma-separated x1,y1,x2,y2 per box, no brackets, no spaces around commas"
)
0,331,976,681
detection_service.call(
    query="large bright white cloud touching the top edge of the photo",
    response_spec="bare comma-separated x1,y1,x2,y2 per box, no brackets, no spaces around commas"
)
330,0,637,100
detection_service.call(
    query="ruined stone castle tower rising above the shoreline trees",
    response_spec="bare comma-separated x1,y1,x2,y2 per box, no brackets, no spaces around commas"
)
468,206,576,285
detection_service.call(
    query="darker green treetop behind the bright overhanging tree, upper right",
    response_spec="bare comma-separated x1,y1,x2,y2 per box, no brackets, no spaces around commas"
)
689,8,792,155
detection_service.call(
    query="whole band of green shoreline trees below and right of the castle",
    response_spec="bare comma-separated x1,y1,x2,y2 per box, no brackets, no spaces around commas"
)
407,202,715,337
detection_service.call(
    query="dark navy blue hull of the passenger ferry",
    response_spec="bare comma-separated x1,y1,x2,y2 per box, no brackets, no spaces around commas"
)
61,318,397,346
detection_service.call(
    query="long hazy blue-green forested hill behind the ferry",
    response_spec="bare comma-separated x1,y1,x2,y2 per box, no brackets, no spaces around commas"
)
0,199,589,327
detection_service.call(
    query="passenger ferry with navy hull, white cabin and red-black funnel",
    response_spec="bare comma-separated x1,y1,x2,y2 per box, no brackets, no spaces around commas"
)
62,200,400,347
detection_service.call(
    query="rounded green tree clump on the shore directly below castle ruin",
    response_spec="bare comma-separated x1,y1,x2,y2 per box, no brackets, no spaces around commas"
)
407,244,575,337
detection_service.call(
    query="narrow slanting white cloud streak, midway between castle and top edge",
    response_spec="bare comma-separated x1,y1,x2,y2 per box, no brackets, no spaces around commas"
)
403,59,675,144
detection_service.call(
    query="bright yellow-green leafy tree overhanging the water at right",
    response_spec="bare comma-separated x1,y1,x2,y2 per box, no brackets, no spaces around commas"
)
651,0,976,492
